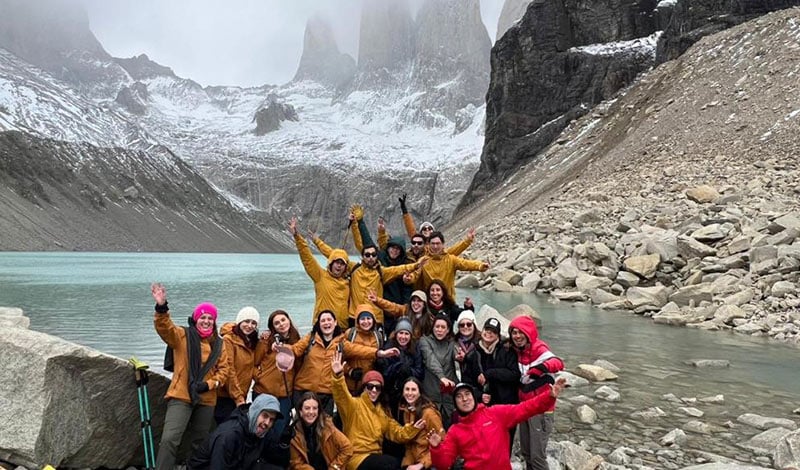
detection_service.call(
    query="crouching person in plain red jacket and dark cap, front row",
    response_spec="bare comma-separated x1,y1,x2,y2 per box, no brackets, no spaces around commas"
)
428,378,567,470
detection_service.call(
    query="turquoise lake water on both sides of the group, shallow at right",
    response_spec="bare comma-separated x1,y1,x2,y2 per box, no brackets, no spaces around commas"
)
0,253,800,464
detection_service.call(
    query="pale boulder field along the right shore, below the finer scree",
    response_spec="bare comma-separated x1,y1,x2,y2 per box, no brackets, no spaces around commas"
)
457,174,800,345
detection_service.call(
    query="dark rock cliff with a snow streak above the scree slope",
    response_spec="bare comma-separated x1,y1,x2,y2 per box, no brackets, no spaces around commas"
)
459,0,800,209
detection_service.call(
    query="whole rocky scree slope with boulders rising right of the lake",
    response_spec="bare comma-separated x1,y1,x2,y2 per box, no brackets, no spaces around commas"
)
452,8,800,343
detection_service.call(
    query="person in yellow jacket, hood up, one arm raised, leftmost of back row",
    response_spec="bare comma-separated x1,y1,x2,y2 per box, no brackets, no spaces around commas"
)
289,217,350,329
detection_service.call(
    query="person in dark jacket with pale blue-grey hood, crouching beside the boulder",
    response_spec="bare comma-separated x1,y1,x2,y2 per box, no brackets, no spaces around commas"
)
186,394,289,470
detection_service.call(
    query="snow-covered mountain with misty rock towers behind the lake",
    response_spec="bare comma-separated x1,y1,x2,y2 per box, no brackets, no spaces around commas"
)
0,0,491,244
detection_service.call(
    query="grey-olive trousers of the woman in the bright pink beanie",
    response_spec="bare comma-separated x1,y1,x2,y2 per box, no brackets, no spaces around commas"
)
156,398,214,470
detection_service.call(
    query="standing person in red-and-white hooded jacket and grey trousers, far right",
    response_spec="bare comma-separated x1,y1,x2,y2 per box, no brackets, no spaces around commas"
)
508,316,564,470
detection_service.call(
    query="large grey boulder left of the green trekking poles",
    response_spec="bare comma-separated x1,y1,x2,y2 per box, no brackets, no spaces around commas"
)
0,318,168,468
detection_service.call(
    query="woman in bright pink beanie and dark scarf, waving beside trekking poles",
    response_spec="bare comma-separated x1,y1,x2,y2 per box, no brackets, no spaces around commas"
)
150,283,230,470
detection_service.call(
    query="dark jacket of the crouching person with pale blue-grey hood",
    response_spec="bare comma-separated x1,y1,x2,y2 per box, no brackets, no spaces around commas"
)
186,409,291,470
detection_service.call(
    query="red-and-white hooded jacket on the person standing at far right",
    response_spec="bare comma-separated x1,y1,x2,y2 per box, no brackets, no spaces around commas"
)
508,315,564,411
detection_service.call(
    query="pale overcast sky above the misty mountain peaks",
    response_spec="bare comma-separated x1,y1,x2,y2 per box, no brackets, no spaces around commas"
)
82,0,503,86
